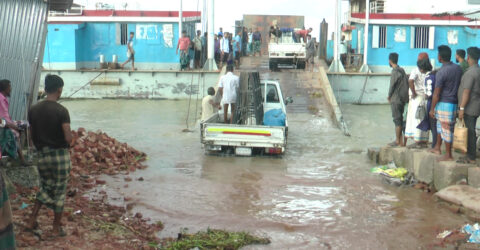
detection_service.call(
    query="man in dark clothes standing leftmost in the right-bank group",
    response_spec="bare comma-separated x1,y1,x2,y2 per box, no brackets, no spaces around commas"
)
388,53,408,147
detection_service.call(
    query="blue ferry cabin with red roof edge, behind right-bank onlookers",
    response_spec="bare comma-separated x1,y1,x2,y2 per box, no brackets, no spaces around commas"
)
348,13,480,73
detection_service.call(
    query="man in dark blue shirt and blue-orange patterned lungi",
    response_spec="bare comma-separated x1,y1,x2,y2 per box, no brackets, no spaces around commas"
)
430,45,463,161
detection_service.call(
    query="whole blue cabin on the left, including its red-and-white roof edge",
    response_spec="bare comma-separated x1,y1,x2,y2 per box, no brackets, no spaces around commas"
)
43,10,201,70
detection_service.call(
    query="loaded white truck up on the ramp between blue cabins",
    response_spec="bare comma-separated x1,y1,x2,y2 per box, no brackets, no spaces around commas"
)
268,32,307,70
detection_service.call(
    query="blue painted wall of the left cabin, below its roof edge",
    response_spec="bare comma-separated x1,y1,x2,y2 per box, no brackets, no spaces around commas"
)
44,23,184,67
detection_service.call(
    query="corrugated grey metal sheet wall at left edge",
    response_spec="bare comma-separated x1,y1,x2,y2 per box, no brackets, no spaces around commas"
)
0,0,48,120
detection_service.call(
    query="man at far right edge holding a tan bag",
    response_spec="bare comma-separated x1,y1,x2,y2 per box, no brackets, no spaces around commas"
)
453,47,480,164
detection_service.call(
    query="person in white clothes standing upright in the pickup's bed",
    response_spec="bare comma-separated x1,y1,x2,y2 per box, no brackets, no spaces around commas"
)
218,65,240,123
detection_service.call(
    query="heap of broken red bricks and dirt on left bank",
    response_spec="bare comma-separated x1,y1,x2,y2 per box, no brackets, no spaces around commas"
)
10,129,163,249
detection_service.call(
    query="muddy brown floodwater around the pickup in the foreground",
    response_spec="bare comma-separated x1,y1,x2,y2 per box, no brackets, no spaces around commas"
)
63,100,466,249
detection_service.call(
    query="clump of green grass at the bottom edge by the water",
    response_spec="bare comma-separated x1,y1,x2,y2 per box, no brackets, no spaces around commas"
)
163,229,270,250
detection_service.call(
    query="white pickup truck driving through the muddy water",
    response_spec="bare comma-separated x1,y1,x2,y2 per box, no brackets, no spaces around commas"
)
200,80,293,156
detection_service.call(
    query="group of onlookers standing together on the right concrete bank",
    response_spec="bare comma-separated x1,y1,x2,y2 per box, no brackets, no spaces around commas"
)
388,45,480,163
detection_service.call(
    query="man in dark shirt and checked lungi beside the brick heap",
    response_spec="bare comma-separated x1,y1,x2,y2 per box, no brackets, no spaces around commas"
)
26,75,72,236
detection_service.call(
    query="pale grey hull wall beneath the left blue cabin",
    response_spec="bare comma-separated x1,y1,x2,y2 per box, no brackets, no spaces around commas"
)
40,70,219,99
